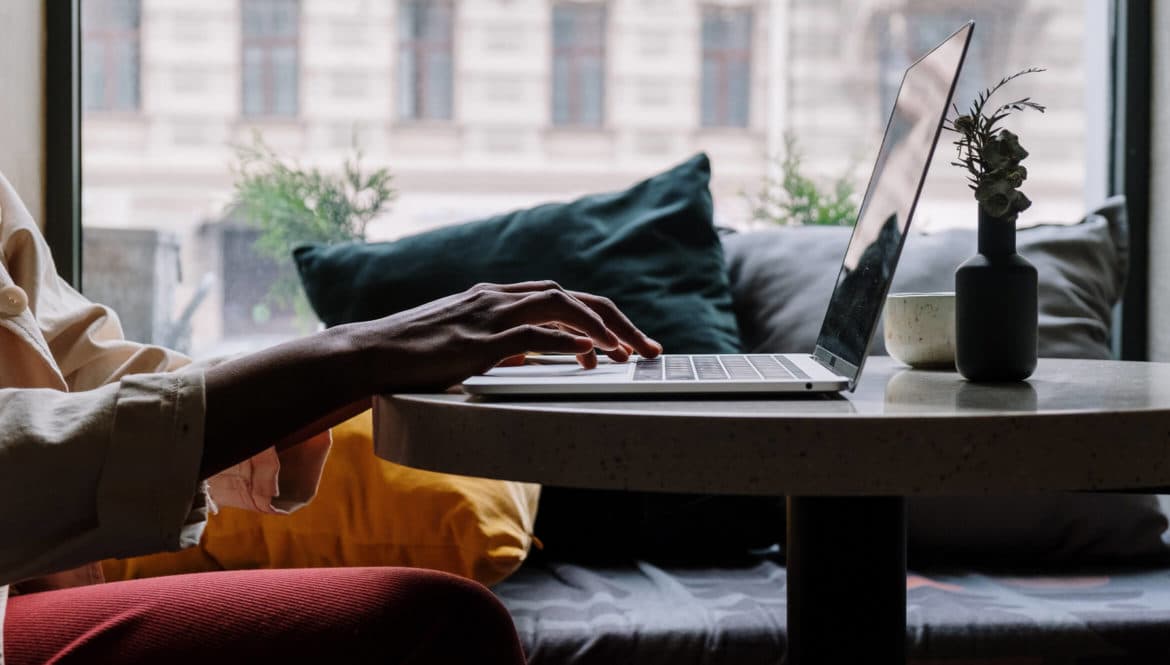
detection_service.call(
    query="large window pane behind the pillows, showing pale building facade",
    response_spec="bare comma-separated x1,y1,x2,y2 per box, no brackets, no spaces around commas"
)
82,0,1107,355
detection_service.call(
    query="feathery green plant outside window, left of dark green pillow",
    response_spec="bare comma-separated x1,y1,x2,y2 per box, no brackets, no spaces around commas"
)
228,133,398,329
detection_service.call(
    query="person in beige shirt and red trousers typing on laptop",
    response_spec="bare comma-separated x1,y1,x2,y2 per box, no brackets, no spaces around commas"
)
0,176,661,665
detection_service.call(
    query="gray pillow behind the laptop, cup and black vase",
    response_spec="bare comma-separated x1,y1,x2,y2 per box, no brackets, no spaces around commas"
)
723,199,1129,358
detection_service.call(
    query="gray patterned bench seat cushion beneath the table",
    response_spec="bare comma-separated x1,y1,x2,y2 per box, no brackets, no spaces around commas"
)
495,560,1170,665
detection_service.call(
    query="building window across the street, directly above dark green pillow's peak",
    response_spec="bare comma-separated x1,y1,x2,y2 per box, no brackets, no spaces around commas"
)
702,7,751,128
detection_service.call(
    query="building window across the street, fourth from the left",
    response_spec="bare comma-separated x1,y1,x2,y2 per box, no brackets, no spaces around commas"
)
552,2,605,126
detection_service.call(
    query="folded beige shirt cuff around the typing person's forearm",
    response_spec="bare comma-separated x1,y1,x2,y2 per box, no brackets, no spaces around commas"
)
97,370,207,557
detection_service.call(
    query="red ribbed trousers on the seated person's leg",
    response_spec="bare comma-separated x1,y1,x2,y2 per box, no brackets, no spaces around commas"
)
4,568,524,665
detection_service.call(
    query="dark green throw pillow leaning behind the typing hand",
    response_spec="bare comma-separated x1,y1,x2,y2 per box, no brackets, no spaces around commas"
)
294,155,741,354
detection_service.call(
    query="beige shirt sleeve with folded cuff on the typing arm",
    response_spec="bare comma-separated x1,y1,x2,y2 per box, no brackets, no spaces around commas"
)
0,371,206,584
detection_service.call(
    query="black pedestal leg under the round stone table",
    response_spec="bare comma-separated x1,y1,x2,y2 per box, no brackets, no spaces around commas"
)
785,496,906,665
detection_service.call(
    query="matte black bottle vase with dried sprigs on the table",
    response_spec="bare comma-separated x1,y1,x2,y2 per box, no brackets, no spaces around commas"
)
943,68,1045,382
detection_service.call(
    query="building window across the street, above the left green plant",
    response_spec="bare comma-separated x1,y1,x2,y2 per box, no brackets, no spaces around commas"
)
241,0,301,117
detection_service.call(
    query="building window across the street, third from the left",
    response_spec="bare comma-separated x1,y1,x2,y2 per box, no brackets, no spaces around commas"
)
398,0,454,121
